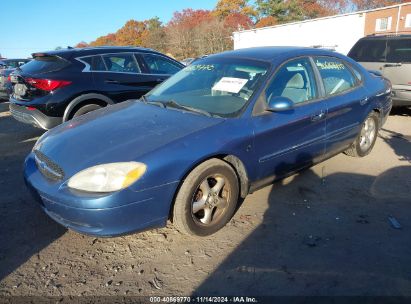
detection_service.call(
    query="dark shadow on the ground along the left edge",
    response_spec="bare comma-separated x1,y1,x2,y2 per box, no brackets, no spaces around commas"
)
0,104,65,282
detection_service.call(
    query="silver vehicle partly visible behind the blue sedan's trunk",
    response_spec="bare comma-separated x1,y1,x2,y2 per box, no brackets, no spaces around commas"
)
348,35,411,107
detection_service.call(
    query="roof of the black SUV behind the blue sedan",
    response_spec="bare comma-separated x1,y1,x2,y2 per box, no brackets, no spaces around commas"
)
32,46,160,59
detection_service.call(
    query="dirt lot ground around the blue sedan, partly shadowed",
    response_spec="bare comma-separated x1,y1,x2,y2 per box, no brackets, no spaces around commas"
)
0,104,411,296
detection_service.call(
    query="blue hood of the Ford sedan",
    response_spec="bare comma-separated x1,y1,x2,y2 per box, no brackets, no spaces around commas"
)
35,101,224,175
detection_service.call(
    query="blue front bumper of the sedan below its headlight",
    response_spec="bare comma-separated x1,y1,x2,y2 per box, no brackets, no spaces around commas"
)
24,155,177,237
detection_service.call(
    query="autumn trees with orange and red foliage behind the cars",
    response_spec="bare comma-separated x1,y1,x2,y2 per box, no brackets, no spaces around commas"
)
76,0,409,59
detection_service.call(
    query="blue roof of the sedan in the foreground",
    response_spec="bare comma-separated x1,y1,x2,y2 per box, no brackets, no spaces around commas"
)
207,46,342,62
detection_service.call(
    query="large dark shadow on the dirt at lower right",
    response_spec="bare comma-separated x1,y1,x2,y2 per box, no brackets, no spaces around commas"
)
193,163,411,296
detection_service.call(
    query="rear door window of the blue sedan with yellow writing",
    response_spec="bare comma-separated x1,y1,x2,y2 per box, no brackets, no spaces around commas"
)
315,57,357,95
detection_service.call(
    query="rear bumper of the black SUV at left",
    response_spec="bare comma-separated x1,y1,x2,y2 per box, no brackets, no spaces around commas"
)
10,102,63,130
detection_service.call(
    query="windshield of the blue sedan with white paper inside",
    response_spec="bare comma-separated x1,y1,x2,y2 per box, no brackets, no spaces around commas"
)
146,58,269,117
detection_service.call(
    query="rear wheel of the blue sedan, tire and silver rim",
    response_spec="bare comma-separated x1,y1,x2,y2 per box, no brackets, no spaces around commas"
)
344,112,379,157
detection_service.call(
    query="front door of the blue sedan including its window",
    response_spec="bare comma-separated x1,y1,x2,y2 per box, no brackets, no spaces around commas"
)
252,57,327,179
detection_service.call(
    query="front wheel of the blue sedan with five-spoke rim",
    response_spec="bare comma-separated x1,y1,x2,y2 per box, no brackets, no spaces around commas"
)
173,158,239,236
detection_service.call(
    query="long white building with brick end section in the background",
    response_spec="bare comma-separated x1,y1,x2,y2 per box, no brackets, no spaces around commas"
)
233,3,411,54
